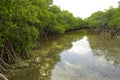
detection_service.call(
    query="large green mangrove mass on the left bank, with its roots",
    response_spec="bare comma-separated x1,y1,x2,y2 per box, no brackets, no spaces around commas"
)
0,0,84,72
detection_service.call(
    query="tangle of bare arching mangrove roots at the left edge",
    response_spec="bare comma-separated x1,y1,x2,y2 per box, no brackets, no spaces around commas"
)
0,39,30,73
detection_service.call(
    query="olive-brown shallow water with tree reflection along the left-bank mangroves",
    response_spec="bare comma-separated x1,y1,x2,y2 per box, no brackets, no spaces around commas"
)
5,30,88,80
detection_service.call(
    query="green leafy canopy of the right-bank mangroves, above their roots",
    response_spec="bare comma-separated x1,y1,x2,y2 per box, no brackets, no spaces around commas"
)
87,7,120,28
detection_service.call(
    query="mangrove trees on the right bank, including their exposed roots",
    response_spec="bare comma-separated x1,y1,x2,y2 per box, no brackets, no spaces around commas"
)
85,7,120,38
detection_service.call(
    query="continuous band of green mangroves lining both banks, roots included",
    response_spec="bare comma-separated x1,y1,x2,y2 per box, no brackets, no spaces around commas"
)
0,0,120,76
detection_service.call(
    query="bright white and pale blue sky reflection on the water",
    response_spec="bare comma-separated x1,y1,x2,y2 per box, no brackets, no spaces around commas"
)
51,36,120,80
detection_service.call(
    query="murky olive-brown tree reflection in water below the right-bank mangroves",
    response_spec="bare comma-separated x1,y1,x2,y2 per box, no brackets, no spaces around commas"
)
89,36,120,66
